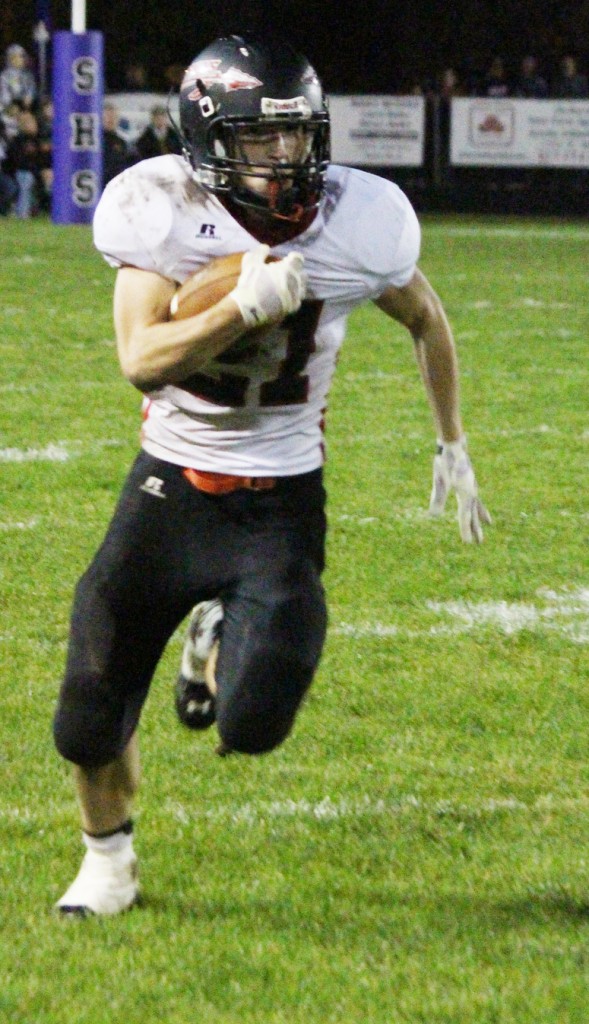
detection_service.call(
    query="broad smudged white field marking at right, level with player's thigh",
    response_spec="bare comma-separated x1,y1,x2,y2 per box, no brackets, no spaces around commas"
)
331,587,589,644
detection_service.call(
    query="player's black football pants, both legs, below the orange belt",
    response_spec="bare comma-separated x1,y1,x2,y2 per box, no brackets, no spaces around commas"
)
54,452,327,768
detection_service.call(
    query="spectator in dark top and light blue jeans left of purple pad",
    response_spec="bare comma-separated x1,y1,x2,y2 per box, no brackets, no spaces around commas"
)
6,111,51,219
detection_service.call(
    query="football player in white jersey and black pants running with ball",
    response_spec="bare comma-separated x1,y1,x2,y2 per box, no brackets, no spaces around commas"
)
54,36,490,914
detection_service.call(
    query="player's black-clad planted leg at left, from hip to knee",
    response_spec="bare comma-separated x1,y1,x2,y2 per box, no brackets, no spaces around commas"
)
54,457,202,765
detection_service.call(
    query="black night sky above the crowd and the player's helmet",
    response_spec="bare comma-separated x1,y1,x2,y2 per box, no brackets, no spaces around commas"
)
0,0,589,92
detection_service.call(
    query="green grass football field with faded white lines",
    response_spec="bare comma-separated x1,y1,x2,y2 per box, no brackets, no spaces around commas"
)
0,211,589,1024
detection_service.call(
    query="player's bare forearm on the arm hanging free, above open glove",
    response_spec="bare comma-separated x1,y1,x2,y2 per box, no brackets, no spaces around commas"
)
415,310,463,441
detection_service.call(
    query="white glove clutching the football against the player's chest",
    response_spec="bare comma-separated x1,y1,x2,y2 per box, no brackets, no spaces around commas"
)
229,246,306,328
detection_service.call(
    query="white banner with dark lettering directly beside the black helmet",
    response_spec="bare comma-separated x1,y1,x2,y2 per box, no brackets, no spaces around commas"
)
329,96,425,167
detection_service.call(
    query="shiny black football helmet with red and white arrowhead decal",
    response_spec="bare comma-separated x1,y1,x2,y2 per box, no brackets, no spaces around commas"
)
180,36,329,220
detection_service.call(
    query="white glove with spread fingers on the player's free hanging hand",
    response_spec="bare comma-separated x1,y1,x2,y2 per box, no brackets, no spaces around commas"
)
429,437,491,544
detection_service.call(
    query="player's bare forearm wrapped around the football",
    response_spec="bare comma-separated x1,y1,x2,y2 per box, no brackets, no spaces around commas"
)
119,297,246,391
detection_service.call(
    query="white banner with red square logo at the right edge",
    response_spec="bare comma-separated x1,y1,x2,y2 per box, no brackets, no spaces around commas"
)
450,99,589,167
